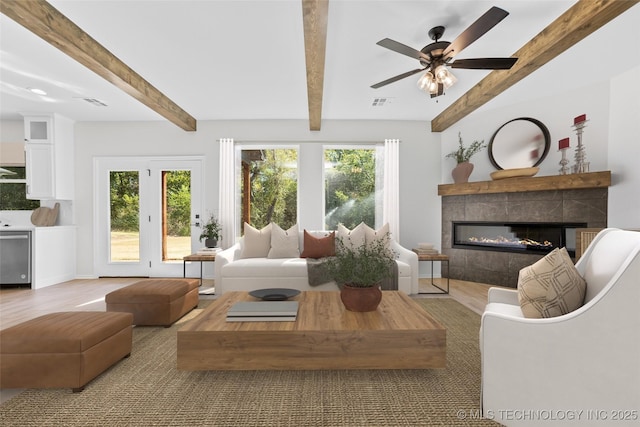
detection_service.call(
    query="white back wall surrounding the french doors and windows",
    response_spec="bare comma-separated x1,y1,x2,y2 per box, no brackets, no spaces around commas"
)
75,120,441,277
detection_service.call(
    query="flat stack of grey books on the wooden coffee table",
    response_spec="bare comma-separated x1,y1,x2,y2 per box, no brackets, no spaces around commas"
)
227,301,298,322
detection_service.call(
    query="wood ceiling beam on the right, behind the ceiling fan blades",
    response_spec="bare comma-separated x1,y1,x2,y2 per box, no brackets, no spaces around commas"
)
431,0,640,132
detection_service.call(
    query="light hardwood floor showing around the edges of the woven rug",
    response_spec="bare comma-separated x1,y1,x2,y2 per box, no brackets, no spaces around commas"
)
0,277,500,329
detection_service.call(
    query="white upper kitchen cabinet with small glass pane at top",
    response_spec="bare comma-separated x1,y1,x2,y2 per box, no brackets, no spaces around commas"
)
24,114,75,200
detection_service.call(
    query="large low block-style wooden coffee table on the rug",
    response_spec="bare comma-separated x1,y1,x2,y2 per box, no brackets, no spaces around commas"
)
178,291,446,371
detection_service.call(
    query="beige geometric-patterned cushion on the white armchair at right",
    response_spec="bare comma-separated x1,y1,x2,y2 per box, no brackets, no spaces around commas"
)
518,248,587,318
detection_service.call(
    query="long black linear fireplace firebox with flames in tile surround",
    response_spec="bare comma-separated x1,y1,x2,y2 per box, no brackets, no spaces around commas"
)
452,221,587,257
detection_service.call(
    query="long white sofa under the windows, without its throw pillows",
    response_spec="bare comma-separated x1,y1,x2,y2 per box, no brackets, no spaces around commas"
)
215,231,418,295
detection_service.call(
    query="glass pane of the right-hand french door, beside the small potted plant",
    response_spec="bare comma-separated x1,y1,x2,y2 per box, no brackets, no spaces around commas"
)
162,171,191,262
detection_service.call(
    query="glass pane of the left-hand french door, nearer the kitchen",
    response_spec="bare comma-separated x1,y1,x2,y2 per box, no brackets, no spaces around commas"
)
109,171,140,262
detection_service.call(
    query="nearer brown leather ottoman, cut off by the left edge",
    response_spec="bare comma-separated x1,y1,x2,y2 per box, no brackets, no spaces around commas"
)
0,311,133,392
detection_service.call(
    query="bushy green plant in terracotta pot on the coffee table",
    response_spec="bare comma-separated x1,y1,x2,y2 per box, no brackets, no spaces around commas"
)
327,233,396,311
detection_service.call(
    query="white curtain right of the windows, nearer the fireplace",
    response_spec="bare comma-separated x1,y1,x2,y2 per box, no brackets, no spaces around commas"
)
382,139,400,241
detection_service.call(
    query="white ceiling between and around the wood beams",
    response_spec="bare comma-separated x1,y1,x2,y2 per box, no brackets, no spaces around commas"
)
0,0,640,126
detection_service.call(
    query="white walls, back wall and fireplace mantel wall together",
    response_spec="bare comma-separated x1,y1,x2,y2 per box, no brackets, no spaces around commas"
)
11,67,640,277
